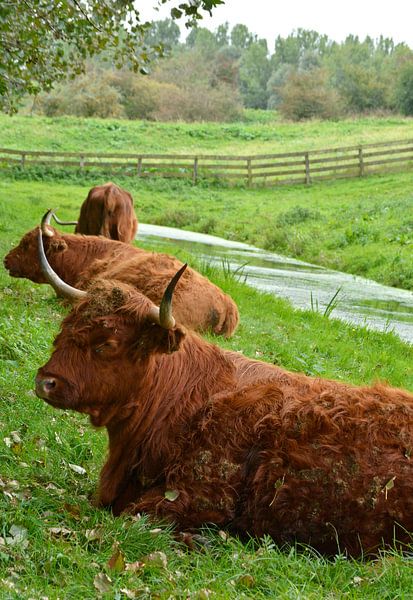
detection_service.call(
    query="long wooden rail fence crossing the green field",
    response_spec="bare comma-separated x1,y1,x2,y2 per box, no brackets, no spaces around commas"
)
0,140,413,186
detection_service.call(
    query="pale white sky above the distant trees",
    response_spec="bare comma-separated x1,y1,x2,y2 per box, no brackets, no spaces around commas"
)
135,0,413,53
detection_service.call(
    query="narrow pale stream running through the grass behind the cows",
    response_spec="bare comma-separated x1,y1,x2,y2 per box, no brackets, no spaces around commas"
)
138,223,413,344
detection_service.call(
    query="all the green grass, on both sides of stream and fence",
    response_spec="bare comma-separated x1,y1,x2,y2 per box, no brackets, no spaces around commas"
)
0,113,413,600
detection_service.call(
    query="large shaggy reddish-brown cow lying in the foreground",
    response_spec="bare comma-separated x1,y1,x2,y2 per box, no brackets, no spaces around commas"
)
36,251,413,555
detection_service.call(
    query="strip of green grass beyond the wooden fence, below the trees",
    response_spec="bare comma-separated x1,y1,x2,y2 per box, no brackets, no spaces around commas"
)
0,111,413,155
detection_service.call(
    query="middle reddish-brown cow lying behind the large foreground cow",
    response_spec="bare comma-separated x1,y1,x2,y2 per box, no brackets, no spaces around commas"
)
4,216,239,337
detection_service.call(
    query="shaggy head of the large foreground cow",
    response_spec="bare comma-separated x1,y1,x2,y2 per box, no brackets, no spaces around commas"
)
36,236,186,426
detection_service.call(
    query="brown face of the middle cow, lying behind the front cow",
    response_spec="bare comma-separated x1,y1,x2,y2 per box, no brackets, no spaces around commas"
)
3,226,67,283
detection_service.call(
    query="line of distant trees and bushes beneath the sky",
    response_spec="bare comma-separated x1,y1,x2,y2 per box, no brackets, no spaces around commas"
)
34,19,413,121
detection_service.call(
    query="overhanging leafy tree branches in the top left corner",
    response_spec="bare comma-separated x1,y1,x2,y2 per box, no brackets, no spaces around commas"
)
0,0,223,113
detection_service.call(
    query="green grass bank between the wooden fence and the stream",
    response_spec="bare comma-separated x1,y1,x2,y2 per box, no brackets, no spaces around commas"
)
0,172,413,289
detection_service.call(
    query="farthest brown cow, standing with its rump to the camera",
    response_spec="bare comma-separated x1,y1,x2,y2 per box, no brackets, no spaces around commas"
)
75,181,138,244
